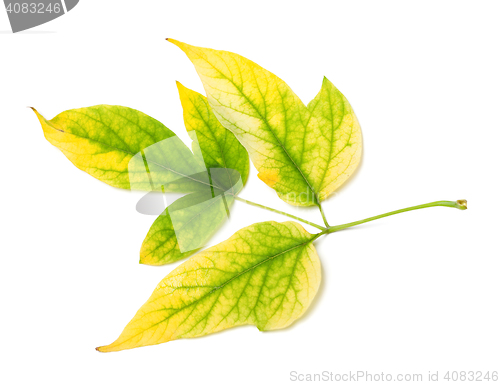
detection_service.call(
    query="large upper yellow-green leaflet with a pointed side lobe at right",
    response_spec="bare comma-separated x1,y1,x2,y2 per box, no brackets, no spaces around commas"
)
168,39,362,206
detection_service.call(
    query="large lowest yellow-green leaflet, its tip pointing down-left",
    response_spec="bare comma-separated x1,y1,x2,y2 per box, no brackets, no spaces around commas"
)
97,222,321,352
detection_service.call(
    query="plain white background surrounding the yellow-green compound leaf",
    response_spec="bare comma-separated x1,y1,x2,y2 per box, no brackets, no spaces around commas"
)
0,0,500,384
